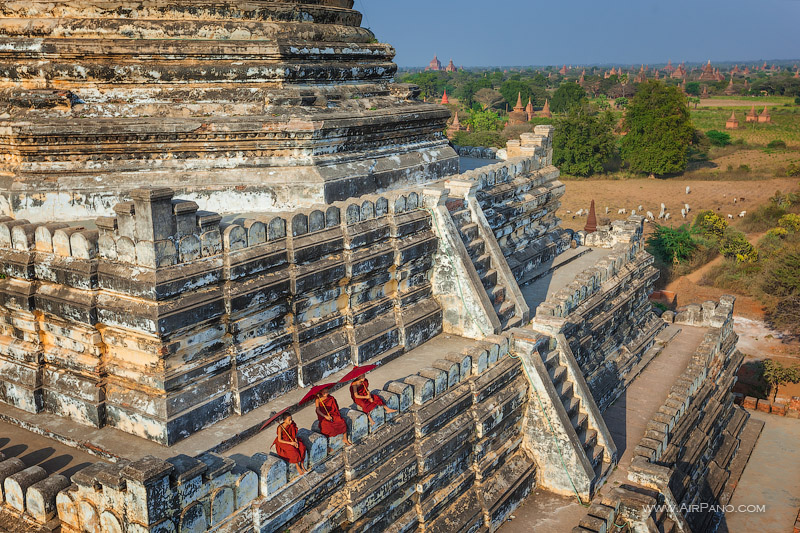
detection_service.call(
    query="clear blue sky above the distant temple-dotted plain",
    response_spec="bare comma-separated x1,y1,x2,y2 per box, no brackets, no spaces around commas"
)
355,0,800,67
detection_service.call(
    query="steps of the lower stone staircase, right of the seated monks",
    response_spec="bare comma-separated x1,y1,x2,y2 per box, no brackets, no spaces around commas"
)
542,350,610,479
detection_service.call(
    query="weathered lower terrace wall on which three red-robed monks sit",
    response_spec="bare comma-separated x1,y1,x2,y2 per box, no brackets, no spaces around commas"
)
51,337,536,532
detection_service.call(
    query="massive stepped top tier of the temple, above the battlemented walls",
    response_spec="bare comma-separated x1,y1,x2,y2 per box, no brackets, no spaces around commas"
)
0,0,458,221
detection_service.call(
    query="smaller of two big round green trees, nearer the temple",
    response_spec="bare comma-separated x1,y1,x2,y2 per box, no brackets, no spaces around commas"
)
553,106,615,177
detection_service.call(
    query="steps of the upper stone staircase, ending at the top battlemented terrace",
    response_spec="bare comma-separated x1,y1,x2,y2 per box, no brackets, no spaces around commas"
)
450,203,522,330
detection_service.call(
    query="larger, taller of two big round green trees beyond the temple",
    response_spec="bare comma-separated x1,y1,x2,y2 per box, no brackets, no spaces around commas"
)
620,80,694,175
